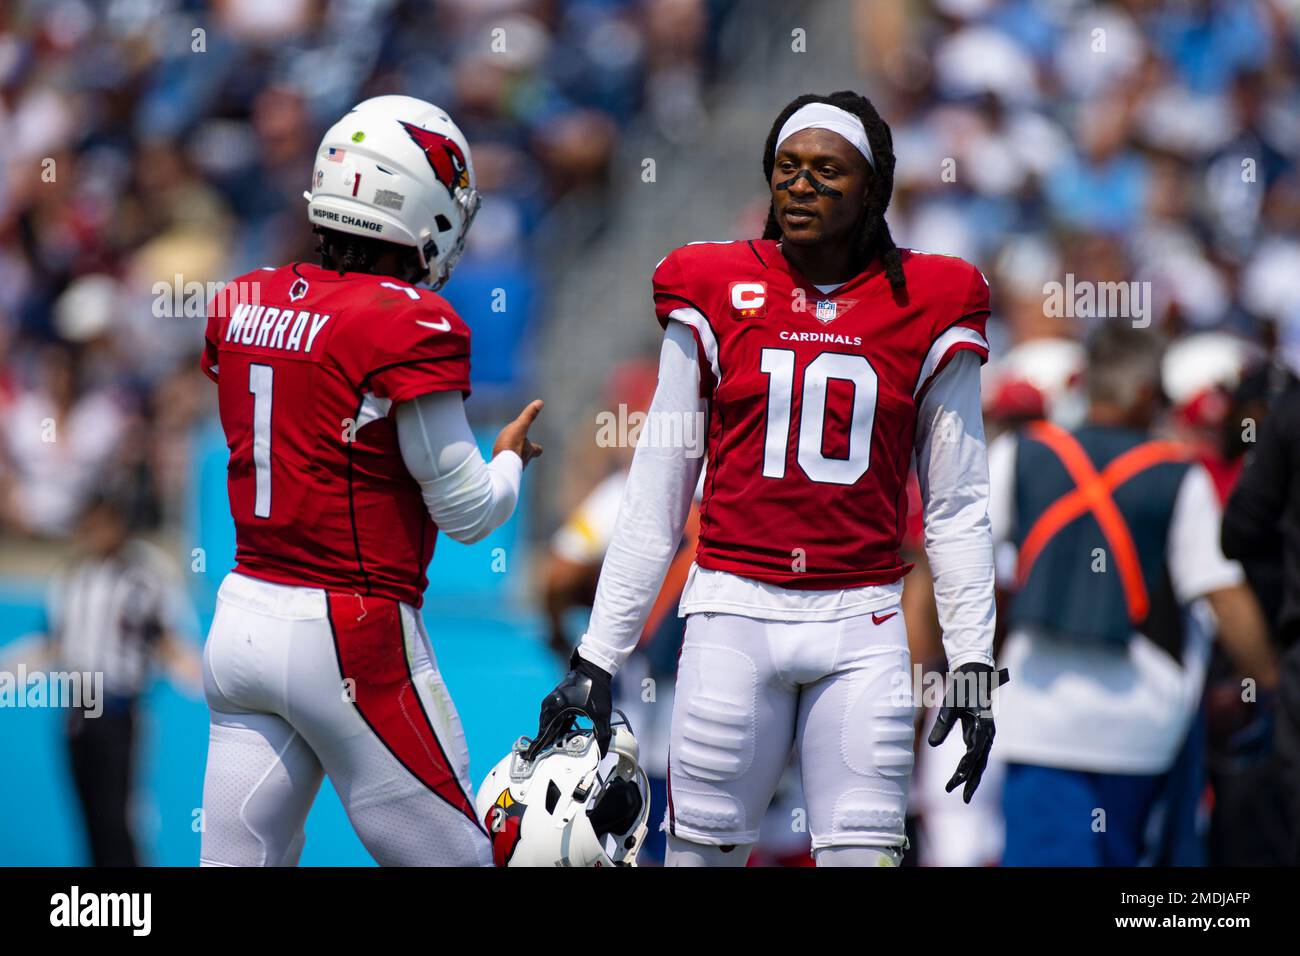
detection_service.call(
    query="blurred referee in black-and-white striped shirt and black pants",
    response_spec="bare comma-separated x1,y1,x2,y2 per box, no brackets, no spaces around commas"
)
42,493,203,866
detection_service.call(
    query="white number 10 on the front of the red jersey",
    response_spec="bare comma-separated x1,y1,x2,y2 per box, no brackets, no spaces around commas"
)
758,349,880,485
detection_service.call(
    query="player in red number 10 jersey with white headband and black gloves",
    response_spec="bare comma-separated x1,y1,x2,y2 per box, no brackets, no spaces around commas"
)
538,92,1005,866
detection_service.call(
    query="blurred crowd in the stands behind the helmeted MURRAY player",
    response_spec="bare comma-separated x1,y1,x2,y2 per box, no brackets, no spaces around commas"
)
0,0,729,538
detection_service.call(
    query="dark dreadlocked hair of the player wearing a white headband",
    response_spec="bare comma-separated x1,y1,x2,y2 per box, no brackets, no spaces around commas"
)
763,90,907,295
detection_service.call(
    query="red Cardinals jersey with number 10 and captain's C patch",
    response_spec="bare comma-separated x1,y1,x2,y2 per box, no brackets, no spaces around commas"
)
654,239,988,589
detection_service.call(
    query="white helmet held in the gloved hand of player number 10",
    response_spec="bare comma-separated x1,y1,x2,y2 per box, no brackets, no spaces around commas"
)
475,714,650,866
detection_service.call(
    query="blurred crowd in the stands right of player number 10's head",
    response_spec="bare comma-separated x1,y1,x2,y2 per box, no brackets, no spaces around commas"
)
867,0,1300,374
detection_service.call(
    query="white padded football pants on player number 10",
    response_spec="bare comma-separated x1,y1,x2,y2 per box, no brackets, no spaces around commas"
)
668,606,914,865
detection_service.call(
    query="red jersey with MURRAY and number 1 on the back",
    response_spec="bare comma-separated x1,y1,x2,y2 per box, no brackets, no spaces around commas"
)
202,263,469,607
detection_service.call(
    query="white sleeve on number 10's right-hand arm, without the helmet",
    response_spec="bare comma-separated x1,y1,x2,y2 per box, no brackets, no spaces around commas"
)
915,351,996,670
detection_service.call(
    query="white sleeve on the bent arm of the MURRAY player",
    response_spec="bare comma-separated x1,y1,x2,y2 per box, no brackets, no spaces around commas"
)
397,392,524,545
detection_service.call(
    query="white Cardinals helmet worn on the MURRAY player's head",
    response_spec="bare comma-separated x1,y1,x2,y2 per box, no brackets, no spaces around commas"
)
303,96,480,289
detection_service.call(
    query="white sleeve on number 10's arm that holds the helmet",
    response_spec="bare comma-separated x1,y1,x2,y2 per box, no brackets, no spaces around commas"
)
579,321,706,674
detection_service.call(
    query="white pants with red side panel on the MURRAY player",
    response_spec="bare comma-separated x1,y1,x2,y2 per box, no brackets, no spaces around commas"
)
200,574,491,866
